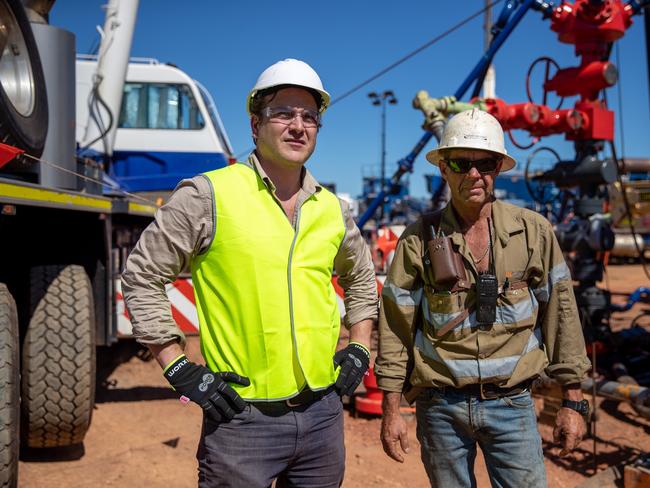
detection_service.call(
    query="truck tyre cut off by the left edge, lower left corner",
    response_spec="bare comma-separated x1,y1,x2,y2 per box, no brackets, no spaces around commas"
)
0,283,20,488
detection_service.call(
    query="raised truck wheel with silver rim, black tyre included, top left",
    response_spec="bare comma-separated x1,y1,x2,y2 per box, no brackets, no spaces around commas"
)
0,0,48,157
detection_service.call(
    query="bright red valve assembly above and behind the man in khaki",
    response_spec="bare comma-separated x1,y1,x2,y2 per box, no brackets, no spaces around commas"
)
474,0,634,147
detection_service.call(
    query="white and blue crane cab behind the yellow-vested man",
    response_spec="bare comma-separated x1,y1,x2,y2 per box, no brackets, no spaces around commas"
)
76,55,233,192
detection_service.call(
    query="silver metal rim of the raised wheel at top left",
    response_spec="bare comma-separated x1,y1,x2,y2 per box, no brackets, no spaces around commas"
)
0,2,35,117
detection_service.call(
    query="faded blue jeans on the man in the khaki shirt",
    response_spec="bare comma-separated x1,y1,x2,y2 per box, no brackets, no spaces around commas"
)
416,388,546,488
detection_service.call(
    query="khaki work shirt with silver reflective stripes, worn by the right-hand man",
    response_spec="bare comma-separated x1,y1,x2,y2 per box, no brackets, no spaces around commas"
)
375,201,590,392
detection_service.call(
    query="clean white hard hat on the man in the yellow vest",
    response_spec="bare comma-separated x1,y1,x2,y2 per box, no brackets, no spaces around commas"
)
246,58,330,114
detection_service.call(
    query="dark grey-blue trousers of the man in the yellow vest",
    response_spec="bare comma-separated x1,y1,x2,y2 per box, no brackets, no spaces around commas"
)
196,391,345,488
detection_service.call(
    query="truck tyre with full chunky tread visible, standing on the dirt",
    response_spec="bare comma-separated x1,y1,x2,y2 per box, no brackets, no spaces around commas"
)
22,265,95,448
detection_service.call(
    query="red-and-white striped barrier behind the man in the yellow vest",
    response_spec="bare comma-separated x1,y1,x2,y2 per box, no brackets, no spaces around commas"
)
115,275,386,338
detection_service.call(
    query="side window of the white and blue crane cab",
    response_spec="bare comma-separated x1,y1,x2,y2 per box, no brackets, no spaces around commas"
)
118,83,205,130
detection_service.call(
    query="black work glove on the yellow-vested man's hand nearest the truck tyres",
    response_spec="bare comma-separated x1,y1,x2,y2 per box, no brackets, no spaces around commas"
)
164,355,251,422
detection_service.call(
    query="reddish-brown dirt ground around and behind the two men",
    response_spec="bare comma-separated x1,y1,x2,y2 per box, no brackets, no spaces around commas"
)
19,265,650,488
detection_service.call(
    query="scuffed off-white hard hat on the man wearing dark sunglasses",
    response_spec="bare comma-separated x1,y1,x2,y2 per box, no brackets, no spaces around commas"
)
427,108,515,171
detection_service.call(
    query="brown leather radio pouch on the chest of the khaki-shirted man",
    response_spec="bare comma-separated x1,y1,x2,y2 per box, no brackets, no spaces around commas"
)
422,210,469,291
